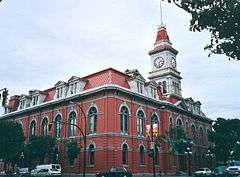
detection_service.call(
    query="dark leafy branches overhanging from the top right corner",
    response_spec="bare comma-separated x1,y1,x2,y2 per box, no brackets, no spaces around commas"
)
168,0,240,60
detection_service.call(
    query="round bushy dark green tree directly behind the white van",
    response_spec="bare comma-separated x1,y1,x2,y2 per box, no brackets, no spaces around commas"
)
25,136,56,164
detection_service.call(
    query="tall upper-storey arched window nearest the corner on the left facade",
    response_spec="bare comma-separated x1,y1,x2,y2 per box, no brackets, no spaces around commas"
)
88,107,97,134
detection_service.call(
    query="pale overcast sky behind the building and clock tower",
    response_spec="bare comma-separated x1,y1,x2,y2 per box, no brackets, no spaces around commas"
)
0,0,240,119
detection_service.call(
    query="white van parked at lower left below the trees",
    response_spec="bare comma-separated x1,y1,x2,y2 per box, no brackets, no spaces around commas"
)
31,164,62,177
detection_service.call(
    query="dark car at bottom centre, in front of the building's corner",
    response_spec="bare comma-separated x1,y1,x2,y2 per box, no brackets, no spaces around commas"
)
96,167,132,177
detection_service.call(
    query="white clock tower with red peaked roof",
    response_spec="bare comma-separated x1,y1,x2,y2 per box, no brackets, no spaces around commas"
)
149,26,182,97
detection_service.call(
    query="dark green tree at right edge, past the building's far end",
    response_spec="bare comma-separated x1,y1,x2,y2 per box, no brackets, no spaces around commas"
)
209,118,240,163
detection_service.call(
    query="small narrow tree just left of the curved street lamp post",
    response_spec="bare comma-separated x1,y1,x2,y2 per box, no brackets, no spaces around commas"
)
66,140,80,165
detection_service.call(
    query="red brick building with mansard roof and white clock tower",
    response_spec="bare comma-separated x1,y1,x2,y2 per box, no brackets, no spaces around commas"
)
1,27,211,173
